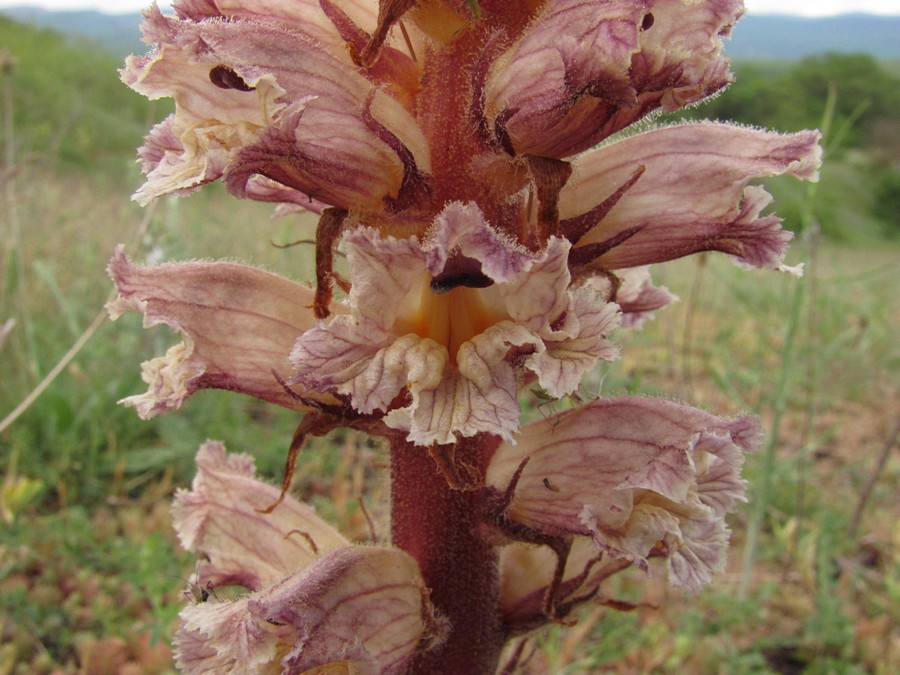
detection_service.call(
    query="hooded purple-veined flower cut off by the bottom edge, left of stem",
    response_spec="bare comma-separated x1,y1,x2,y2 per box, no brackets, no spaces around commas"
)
175,546,441,675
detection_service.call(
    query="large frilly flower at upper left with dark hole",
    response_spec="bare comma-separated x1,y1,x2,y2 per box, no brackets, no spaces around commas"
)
123,0,427,211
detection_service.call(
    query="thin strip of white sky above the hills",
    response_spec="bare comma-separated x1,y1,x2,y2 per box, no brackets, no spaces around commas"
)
0,0,900,16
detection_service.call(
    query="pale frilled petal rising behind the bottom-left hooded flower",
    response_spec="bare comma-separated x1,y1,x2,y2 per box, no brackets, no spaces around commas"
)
172,441,349,590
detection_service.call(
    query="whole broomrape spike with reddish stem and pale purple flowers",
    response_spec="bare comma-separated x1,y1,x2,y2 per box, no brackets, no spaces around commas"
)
109,0,820,673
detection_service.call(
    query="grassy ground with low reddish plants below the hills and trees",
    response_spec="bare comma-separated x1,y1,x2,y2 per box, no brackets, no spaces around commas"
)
0,154,900,673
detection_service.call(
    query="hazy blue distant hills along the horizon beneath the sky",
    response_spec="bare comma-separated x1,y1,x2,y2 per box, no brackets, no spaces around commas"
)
0,7,900,61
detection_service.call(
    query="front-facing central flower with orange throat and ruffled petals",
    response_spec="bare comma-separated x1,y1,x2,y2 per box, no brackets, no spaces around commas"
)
291,203,618,445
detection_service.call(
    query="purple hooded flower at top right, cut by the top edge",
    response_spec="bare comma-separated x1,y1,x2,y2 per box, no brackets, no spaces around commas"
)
486,0,743,158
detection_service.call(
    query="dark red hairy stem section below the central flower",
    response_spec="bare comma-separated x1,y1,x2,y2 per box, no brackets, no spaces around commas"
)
391,436,504,675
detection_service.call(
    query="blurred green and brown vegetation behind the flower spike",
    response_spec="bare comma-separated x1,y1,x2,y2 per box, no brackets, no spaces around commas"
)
0,14,900,675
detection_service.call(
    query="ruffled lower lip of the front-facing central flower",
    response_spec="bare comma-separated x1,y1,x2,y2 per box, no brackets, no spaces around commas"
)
291,317,536,445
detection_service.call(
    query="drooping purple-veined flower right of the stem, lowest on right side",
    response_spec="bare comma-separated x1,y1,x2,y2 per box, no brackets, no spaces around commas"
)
485,397,761,625
